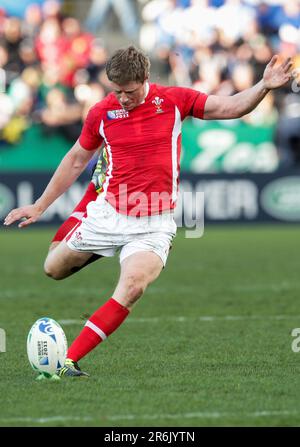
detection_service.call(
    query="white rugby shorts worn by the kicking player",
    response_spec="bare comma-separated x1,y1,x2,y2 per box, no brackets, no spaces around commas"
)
66,195,177,265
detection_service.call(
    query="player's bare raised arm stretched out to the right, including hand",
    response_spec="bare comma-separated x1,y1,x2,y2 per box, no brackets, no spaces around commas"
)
203,55,293,120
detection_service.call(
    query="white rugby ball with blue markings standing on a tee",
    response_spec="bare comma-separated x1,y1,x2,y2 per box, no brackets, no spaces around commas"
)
27,317,68,375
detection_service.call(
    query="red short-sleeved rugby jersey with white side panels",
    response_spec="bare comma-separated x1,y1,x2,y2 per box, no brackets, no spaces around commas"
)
79,84,207,216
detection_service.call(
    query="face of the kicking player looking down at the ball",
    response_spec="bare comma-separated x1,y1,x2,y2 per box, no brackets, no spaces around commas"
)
111,80,147,110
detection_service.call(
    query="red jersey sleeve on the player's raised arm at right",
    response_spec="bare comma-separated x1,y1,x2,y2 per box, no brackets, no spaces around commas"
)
168,87,208,120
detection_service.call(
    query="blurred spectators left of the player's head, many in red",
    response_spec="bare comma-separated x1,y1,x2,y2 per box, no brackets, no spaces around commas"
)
0,0,108,143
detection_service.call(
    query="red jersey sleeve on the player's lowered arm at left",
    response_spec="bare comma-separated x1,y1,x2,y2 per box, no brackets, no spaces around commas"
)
79,106,103,151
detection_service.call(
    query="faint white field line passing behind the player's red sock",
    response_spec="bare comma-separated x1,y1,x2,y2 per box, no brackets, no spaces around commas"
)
58,315,300,326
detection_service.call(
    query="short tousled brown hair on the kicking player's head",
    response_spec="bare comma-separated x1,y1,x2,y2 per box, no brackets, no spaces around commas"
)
106,45,150,85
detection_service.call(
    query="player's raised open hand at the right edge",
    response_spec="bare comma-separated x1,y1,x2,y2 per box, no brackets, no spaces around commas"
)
263,55,293,90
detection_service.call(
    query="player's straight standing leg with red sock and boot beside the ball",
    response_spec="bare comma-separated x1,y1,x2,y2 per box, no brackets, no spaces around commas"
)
59,251,163,377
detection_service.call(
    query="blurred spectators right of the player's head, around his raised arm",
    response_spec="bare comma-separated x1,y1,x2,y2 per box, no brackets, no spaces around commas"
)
140,0,300,167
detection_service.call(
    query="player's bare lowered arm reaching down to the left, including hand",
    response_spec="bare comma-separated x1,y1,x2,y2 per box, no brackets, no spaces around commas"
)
4,141,95,228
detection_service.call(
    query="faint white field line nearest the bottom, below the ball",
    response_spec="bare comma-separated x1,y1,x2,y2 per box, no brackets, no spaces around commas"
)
0,410,299,424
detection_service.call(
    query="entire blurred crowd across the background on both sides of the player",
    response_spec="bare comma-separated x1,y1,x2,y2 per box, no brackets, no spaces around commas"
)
0,0,300,166
